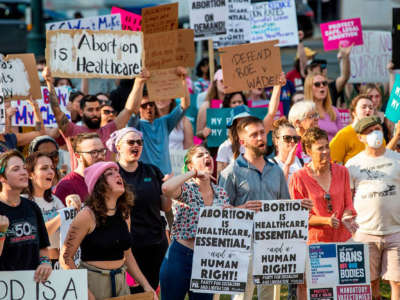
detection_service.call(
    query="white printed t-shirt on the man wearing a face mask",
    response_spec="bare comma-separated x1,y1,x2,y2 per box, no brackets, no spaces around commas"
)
346,149,400,235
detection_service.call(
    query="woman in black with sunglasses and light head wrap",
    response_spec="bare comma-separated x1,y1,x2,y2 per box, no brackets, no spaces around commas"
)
106,127,172,293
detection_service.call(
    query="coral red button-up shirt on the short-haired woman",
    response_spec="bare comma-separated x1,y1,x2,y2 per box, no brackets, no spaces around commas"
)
289,163,356,244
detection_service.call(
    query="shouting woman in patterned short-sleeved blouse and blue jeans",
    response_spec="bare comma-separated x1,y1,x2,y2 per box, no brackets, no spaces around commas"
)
160,146,229,300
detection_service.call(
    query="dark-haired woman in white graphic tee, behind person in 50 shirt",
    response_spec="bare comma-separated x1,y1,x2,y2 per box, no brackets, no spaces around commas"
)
23,152,81,268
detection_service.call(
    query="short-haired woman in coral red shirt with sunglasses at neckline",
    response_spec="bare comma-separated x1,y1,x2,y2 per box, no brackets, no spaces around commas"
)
289,127,357,299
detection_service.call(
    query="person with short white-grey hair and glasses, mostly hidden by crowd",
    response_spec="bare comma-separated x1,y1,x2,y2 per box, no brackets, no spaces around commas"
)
288,100,319,163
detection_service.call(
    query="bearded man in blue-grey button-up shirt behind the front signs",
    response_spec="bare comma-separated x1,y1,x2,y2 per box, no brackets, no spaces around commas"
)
219,116,290,300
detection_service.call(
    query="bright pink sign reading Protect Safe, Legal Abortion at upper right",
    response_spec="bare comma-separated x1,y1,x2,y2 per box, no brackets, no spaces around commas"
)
320,18,363,51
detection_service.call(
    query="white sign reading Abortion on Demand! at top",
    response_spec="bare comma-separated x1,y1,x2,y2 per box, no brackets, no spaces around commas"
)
189,0,228,41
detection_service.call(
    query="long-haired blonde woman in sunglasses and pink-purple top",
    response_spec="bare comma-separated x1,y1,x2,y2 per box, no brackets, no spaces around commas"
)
304,74,343,141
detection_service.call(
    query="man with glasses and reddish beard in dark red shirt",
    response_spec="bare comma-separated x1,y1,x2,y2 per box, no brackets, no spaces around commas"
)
54,132,107,205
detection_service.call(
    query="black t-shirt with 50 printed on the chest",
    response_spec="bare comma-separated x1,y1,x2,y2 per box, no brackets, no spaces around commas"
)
0,197,50,271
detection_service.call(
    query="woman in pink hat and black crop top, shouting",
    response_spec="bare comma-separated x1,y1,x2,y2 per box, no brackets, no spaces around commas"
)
60,162,158,300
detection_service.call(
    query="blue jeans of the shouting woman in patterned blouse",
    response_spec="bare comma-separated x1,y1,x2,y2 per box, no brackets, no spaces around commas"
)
160,240,213,300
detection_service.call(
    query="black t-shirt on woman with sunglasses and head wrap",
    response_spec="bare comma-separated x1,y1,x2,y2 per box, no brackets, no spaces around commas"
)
120,162,166,247
